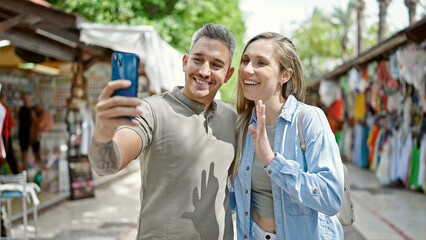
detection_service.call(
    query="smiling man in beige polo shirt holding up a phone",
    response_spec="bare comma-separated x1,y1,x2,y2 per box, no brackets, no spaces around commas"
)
89,24,236,239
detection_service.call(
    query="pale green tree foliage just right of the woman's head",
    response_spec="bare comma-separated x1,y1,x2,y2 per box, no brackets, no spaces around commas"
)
291,6,379,83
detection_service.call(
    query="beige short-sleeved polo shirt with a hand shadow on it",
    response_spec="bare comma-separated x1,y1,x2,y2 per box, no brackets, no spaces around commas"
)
123,87,236,240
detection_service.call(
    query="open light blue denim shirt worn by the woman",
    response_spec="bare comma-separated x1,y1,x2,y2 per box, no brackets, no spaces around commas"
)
229,95,343,240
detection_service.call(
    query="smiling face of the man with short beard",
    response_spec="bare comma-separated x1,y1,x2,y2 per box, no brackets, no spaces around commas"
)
182,37,234,106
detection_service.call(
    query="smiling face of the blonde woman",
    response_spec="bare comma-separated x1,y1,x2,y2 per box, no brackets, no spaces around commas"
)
238,39,285,104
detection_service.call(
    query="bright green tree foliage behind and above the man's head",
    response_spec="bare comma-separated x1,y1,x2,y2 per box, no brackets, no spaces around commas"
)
47,0,246,102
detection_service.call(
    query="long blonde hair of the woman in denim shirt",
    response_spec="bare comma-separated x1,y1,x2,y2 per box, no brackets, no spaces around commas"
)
232,32,306,179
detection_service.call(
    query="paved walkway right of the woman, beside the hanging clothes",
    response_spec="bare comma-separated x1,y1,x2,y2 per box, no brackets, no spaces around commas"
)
346,164,426,240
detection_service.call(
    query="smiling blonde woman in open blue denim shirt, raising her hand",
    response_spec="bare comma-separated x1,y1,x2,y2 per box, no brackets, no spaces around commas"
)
230,32,343,240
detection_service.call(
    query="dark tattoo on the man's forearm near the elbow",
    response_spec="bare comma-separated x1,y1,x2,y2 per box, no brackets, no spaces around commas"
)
89,138,120,175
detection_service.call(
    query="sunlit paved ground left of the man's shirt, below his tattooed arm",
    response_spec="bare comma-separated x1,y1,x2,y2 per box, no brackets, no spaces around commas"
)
7,162,140,240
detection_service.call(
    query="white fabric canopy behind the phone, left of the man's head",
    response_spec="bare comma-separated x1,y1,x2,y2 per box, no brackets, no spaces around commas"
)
78,23,184,93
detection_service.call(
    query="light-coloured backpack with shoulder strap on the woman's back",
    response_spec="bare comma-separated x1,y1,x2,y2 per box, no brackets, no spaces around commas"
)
297,106,355,226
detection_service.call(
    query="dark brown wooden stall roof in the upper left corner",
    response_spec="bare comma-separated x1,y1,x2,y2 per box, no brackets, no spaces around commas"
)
0,0,109,63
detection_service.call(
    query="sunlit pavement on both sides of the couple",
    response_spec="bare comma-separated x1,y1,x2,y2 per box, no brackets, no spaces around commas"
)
8,164,426,240
